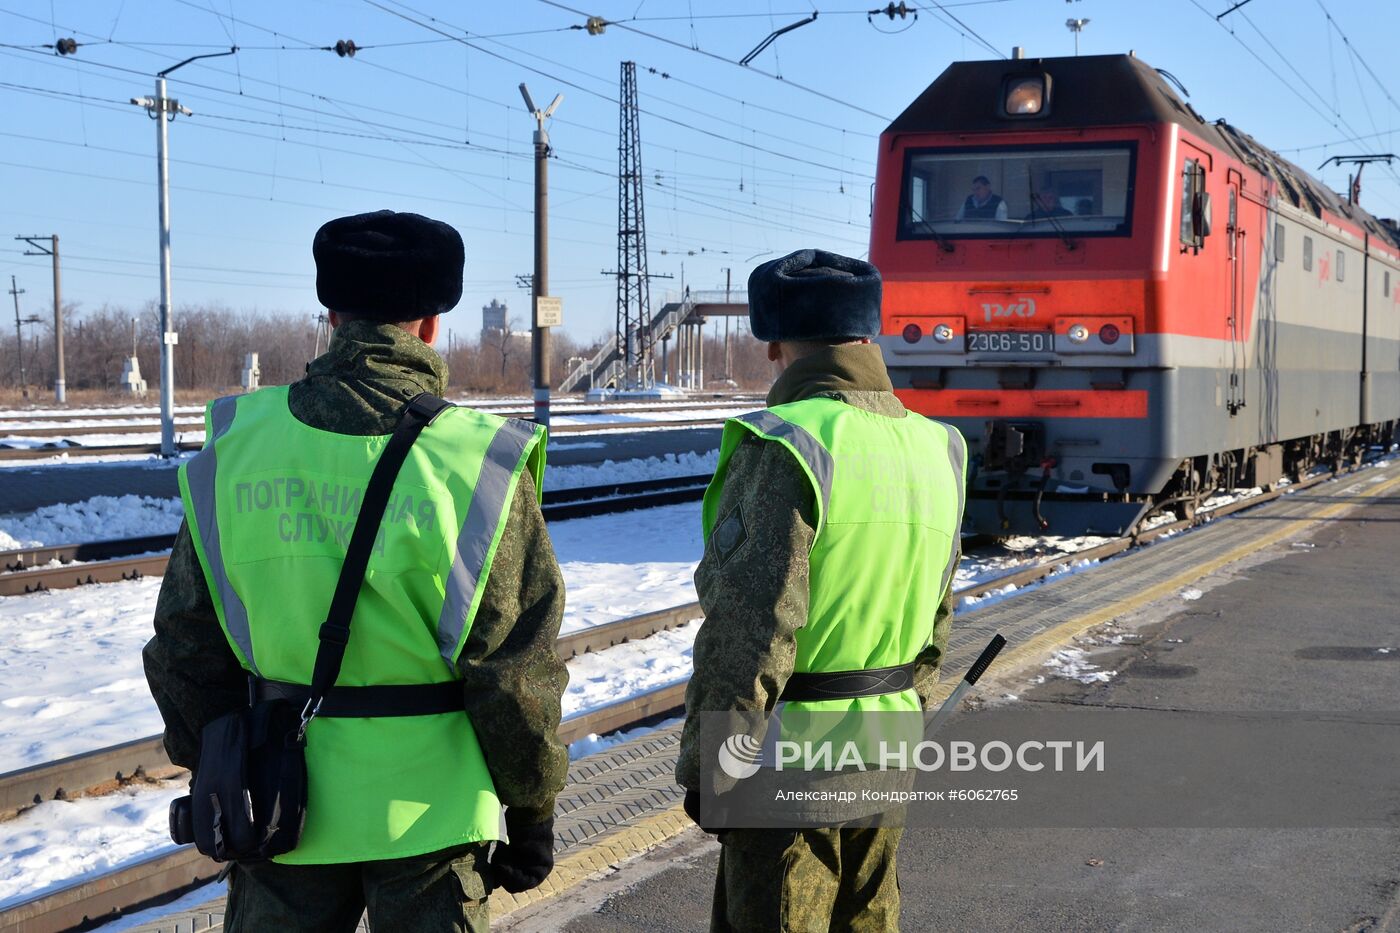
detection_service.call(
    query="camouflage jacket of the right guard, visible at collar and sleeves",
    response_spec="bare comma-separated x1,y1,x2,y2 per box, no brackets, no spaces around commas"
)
676,345,953,790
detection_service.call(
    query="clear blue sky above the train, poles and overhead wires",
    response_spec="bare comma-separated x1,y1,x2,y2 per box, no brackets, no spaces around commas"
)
0,0,1400,340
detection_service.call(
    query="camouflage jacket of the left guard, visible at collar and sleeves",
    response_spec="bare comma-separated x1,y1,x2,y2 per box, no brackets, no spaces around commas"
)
143,321,568,822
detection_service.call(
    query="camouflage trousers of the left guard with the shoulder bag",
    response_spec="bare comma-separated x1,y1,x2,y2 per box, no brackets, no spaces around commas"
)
224,843,490,933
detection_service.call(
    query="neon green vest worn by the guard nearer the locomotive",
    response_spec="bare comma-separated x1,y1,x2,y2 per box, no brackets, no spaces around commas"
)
703,398,967,713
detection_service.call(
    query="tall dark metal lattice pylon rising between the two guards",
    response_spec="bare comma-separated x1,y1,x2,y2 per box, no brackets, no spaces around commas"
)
617,62,654,388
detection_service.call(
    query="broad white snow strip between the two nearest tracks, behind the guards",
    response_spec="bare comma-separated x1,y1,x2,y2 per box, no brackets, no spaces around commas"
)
0,503,700,772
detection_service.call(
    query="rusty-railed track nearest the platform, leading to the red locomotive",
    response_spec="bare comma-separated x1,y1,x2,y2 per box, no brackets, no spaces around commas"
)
0,456,1377,932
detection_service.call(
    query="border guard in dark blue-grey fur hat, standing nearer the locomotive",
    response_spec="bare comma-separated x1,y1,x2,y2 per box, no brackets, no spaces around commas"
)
676,249,966,933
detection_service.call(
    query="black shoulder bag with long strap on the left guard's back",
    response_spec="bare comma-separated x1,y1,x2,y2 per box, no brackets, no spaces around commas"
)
169,394,449,862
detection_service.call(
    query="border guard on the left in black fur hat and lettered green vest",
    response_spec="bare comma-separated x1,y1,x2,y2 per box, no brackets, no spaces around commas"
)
144,210,568,933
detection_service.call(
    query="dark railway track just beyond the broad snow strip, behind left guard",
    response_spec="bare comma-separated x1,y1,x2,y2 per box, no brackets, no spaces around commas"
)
0,475,710,597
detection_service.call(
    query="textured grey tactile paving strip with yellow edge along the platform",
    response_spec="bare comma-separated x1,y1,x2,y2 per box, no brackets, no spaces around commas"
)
130,464,1400,933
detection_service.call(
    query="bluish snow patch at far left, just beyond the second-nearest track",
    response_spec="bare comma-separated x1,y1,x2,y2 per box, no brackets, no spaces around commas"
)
0,496,185,551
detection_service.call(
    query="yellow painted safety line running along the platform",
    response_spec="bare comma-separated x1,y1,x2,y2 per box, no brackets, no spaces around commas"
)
491,462,1400,918
